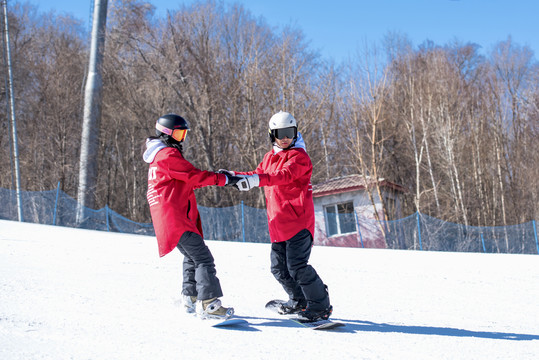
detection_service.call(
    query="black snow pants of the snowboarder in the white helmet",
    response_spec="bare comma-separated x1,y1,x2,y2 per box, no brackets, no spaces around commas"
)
271,229,330,311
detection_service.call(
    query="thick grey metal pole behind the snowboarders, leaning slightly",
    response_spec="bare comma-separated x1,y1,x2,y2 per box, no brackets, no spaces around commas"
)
77,0,108,224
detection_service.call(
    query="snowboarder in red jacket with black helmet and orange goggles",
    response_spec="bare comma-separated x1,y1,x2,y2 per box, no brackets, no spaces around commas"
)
143,114,241,319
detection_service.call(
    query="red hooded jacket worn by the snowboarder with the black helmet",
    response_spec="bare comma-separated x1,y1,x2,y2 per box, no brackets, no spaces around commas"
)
145,142,226,256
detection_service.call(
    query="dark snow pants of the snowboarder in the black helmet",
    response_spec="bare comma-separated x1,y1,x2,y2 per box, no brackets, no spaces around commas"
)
176,231,223,300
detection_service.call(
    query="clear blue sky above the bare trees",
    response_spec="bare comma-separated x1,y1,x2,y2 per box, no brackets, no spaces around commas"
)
23,0,539,62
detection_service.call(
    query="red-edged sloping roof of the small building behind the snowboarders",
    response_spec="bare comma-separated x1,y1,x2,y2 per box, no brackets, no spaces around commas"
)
313,174,406,197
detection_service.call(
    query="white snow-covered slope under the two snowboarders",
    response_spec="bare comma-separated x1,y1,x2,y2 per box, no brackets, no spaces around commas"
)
0,220,539,360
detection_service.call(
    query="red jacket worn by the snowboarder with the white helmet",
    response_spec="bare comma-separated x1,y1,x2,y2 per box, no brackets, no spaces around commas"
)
237,147,314,242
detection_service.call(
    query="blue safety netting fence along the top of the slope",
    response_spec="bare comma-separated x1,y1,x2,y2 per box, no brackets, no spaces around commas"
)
0,188,539,254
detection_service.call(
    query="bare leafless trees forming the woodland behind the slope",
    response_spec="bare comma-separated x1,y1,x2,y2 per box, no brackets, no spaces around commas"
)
0,0,539,226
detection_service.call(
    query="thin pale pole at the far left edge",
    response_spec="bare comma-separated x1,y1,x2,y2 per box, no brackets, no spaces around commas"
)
2,0,24,222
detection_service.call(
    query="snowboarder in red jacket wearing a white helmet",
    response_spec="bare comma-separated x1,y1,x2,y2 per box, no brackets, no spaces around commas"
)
220,111,333,322
